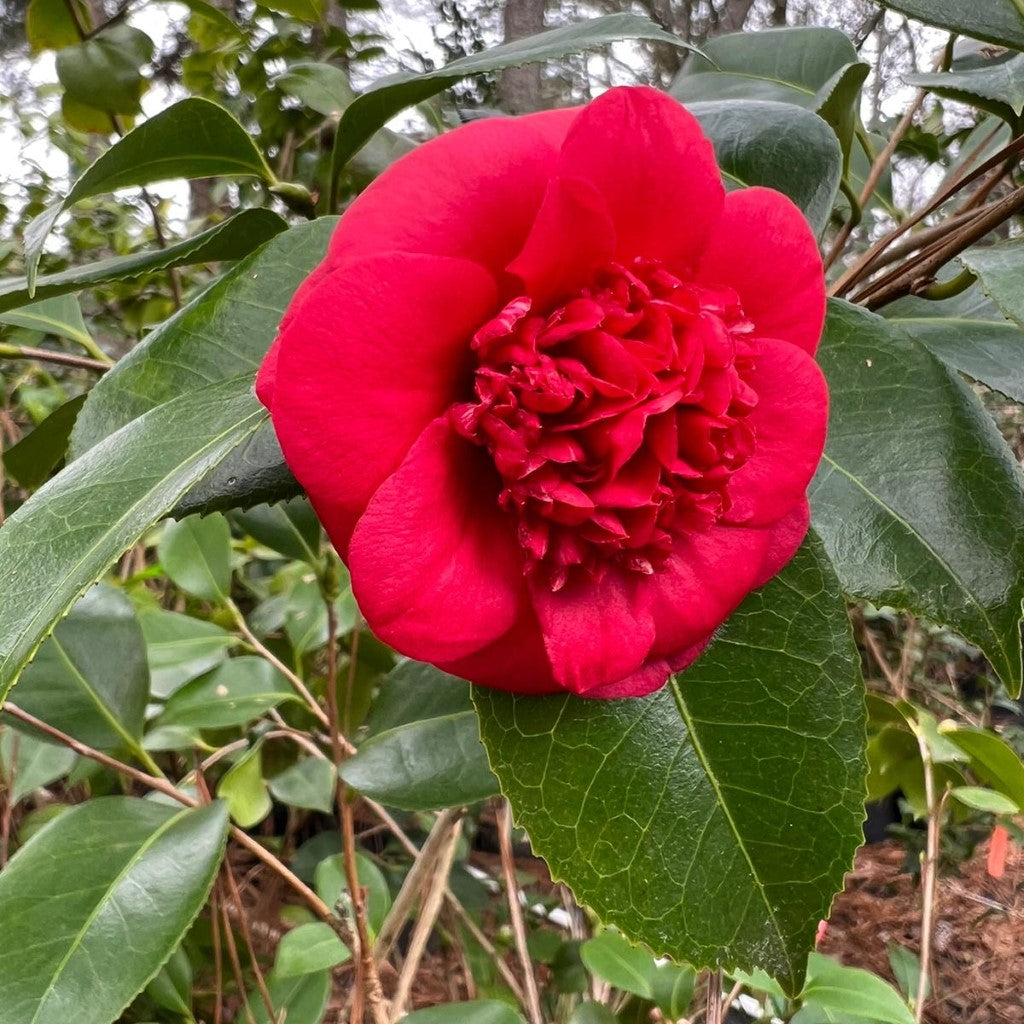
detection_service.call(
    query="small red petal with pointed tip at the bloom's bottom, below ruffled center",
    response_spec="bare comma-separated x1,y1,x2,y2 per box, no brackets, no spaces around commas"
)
530,569,654,694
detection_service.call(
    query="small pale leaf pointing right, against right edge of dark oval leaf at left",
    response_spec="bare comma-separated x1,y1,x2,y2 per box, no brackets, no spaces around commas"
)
138,608,239,699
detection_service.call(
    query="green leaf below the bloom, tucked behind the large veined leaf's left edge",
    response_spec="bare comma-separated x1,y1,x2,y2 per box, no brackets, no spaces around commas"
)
340,704,498,811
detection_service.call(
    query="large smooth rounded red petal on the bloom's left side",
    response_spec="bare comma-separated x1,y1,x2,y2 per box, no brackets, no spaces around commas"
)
270,253,497,556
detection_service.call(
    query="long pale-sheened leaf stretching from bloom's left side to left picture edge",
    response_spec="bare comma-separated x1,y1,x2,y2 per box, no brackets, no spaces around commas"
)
0,375,266,700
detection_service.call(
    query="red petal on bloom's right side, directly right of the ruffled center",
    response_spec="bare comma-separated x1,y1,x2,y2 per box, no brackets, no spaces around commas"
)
728,339,828,526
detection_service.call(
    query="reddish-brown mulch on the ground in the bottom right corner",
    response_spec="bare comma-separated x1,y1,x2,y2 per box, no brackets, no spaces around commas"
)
819,842,1024,1024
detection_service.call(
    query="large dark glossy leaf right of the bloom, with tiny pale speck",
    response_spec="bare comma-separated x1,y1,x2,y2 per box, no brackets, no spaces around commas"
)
810,300,1024,693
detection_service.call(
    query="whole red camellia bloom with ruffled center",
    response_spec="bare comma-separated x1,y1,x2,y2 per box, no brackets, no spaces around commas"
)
257,88,827,697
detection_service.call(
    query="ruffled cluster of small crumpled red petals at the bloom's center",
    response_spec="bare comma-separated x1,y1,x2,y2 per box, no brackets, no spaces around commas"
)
451,260,757,591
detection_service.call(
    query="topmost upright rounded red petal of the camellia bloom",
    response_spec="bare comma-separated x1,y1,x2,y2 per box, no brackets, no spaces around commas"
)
559,87,724,271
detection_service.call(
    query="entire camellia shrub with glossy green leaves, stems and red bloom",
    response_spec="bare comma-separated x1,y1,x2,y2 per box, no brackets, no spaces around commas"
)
0,6,1024,1024
